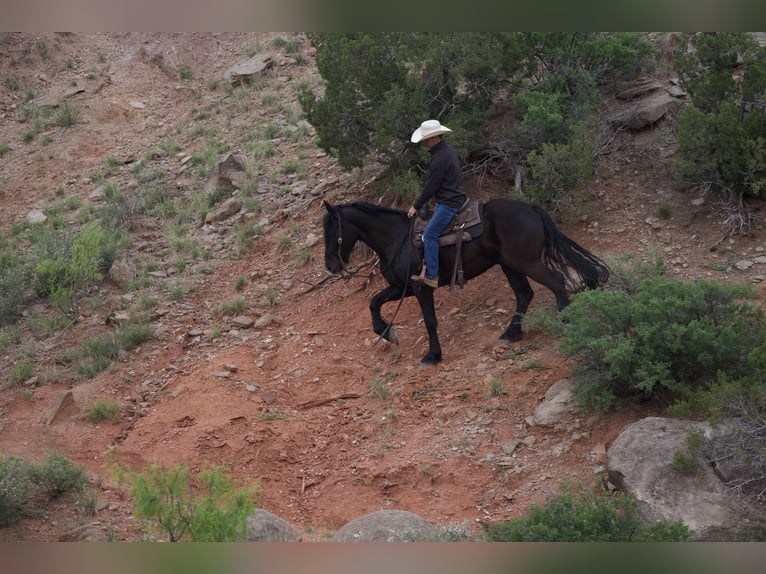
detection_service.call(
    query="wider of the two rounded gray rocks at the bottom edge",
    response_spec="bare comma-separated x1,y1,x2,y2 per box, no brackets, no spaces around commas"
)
330,510,439,542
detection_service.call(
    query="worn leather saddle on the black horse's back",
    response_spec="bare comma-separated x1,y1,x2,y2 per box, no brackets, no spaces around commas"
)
412,200,484,290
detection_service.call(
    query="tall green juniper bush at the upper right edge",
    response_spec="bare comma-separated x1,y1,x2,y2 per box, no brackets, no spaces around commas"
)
675,32,766,207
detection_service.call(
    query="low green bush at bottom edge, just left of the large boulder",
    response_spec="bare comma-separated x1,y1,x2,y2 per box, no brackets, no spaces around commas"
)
489,484,691,542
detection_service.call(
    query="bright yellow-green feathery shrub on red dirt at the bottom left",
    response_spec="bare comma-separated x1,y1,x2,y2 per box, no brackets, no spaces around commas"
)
118,464,261,542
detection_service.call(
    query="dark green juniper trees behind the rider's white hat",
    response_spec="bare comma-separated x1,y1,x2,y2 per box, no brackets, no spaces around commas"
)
300,32,651,205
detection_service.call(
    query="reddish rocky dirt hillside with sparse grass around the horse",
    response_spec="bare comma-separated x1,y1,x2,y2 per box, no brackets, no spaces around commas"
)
0,33,766,541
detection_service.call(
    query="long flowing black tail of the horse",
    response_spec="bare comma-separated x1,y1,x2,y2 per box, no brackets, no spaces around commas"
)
532,205,609,291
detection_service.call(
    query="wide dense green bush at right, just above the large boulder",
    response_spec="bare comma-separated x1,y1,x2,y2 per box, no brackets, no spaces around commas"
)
560,277,763,410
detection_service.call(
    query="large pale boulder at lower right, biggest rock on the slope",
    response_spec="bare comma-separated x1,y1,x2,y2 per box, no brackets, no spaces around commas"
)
607,417,758,541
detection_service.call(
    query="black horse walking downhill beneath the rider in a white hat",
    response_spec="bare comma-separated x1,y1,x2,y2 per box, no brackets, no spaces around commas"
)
324,198,609,366
